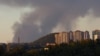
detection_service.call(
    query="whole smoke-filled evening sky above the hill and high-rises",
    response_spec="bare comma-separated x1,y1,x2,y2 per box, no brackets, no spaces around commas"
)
0,0,100,43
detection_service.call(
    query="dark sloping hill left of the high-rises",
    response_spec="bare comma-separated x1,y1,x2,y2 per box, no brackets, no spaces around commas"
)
33,33,56,46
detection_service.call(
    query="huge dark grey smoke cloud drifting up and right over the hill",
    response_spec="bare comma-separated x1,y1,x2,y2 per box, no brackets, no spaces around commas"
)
0,0,100,42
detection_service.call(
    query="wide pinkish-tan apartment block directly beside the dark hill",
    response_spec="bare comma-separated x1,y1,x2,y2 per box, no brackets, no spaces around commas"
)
55,32,69,44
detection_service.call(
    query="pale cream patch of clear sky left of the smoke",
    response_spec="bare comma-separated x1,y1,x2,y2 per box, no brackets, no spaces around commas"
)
0,5,30,42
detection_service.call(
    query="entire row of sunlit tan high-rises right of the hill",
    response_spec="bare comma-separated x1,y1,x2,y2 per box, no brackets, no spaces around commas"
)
55,30,94,44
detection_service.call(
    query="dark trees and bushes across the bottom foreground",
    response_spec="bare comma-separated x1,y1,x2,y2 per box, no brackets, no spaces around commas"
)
0,40,100,56
